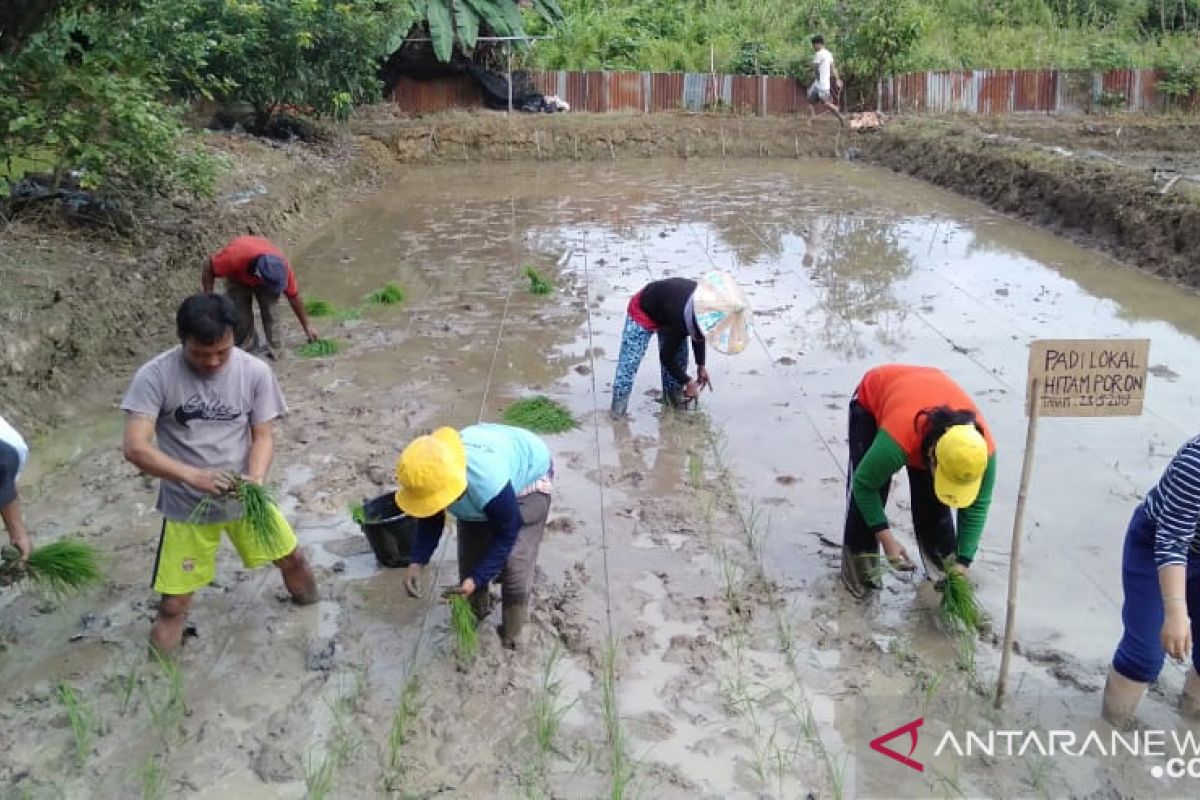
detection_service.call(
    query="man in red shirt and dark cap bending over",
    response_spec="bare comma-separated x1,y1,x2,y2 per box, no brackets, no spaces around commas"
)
200,236,317,357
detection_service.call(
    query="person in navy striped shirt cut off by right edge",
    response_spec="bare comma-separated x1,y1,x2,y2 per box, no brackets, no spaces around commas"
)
1102,437,1200,726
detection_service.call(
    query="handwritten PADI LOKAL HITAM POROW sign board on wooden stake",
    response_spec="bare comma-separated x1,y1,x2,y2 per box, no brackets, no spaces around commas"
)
1026,339,1150,416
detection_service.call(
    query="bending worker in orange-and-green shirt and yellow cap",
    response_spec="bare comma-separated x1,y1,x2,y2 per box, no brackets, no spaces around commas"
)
841,363,996,597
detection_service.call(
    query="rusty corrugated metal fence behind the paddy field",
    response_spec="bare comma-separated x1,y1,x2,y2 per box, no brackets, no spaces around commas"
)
392,70,1190,115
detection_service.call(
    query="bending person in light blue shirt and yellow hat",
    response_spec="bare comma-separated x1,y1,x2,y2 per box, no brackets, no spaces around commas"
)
396,423,553,648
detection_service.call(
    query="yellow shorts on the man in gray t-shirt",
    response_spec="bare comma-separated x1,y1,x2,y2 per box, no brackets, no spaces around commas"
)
154,507,296,595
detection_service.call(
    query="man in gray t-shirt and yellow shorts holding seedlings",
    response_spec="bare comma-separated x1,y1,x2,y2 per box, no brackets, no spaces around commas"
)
121,294,317,651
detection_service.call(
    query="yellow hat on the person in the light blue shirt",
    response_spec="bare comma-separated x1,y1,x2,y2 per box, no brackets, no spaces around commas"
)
396,428,467,519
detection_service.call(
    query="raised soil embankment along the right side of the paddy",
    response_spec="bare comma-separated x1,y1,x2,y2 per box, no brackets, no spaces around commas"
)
858,120,1200,288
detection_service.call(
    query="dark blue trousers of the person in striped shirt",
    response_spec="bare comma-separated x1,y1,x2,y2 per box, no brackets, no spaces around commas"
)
1112,505,1200,684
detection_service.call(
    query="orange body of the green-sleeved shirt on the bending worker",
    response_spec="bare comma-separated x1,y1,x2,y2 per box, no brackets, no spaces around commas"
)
858,363,996,469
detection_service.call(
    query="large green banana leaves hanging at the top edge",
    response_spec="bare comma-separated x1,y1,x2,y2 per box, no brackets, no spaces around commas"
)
416,0,563,61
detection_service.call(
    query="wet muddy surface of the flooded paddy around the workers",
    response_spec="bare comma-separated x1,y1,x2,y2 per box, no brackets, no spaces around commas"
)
0,160,1200,798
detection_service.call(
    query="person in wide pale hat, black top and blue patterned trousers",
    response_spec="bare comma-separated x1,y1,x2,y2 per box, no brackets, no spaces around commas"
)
611,271,751,420
